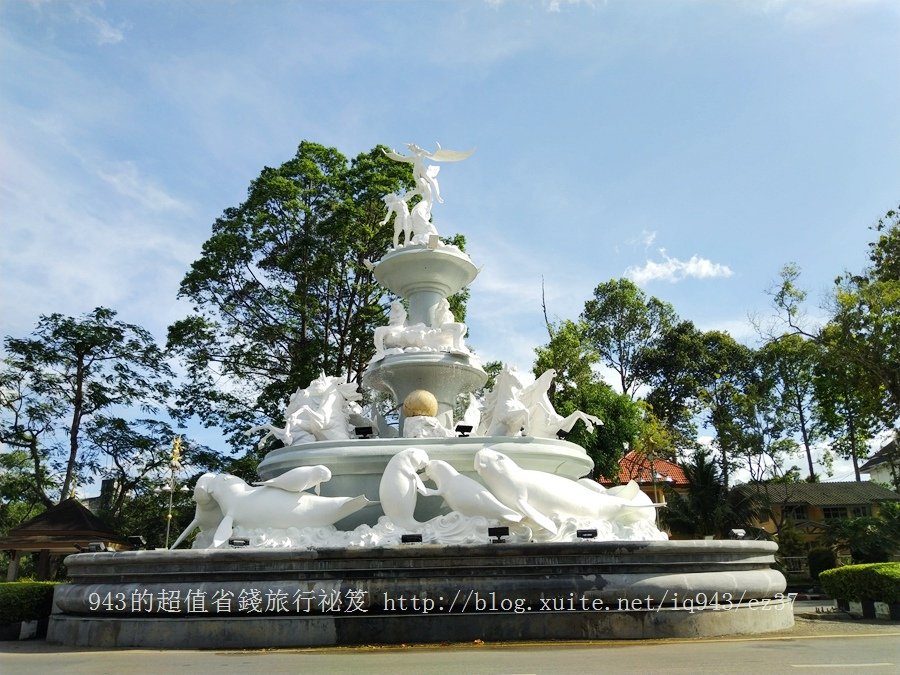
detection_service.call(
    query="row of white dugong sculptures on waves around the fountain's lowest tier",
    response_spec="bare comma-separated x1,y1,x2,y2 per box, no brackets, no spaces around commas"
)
173,447,666,548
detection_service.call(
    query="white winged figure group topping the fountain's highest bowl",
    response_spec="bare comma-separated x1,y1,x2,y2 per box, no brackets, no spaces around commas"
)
382,142,475,248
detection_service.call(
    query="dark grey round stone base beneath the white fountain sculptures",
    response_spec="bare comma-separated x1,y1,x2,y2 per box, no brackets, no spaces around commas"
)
47,540,793,649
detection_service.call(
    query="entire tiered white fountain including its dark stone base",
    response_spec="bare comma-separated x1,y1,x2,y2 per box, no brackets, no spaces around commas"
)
49,145,793,648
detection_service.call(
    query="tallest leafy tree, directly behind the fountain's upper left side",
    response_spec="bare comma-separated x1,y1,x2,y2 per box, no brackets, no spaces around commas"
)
169,141,418,447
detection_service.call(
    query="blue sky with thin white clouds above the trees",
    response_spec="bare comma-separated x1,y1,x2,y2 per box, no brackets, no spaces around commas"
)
0,0,900,478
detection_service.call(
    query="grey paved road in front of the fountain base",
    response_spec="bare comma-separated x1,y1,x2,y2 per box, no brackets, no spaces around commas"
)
0,601,900,675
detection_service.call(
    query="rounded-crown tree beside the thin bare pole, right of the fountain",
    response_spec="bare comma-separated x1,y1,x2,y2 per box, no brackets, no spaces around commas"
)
581,279,676,398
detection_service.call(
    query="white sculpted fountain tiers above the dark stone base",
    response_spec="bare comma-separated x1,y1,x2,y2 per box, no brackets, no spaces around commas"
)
176,144,666,548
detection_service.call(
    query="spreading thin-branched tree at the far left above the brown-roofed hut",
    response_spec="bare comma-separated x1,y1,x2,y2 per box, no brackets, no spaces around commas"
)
0,307,173,506
